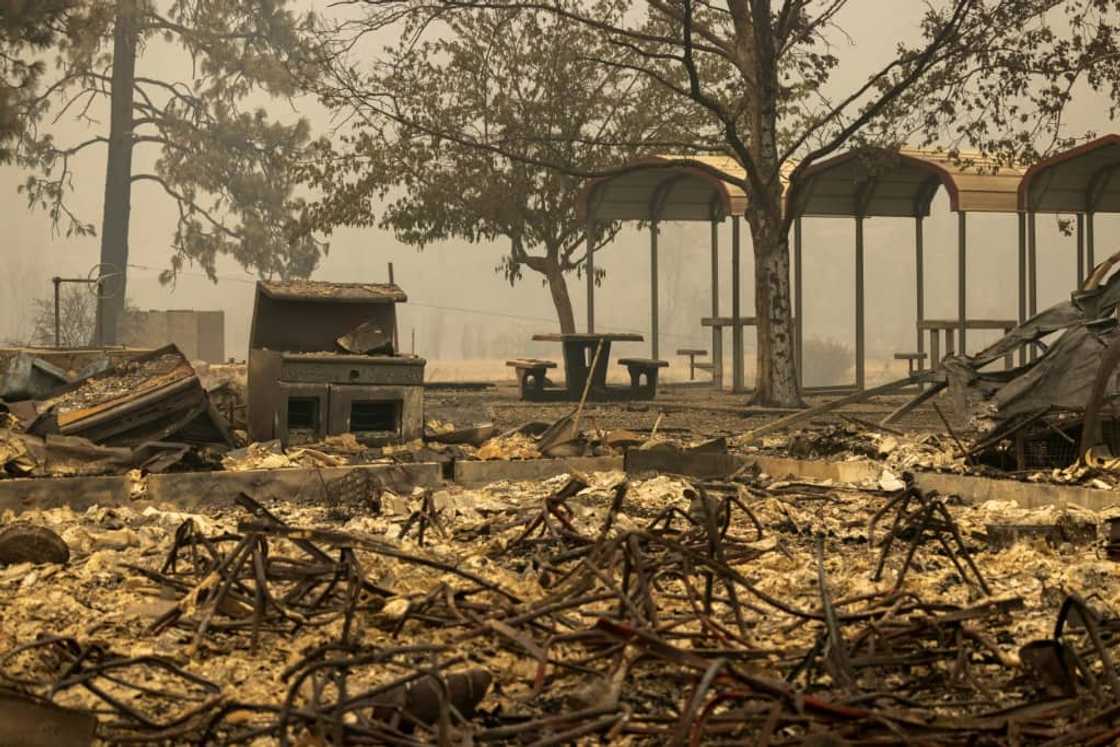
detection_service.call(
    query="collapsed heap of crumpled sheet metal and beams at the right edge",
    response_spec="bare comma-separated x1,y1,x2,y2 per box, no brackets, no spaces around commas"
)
734,250,1120,487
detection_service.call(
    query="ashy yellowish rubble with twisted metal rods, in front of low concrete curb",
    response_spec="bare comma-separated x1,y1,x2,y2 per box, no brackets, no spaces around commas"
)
0,473,1120,746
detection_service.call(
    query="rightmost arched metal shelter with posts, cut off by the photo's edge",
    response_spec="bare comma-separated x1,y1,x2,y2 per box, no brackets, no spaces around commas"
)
1018,133,1120,304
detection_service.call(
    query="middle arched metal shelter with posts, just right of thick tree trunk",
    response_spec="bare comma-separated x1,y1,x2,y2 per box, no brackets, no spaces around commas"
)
786,148,1025,389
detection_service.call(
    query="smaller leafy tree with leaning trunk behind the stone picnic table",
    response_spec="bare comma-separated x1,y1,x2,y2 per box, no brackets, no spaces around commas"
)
315,2,711,332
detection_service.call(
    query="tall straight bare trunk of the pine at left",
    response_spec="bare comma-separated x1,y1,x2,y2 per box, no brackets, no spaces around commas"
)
95,0,137,345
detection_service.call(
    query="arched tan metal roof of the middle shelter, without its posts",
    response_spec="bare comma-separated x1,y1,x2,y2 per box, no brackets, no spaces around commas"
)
787,148,1026,217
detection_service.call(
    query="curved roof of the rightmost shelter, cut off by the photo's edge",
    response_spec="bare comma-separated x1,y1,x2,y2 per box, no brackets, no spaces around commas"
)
1018,134,1120,213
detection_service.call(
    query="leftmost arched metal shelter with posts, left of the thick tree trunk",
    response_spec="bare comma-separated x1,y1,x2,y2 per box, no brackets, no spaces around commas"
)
577,156,747,392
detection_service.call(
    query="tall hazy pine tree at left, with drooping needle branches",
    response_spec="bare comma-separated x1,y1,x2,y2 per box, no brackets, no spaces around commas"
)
15,0,325,340
